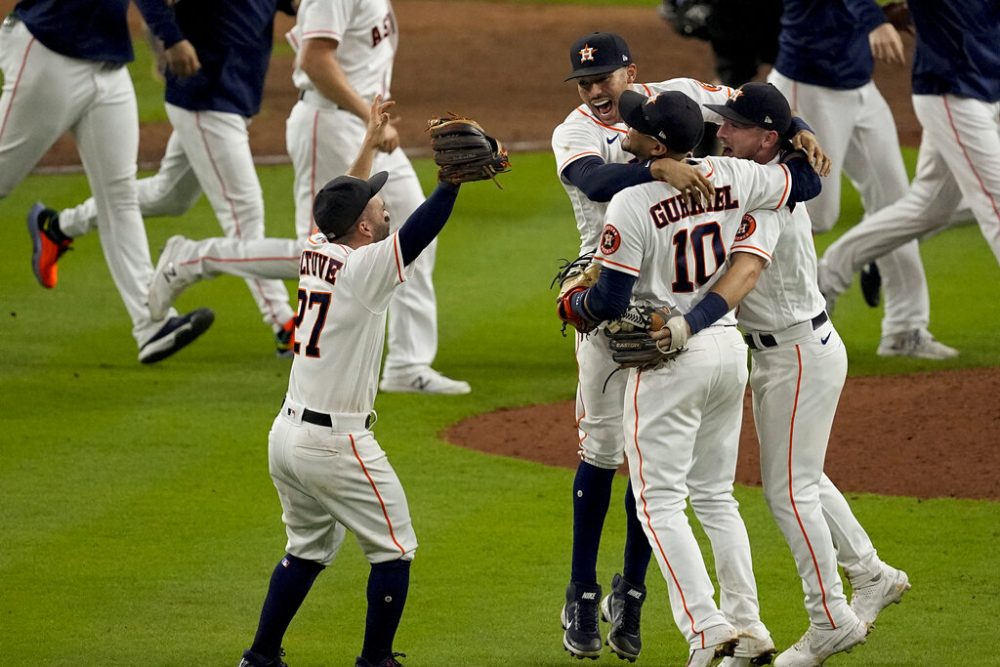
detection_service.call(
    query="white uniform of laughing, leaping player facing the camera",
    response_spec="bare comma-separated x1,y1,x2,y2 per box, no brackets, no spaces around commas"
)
552,79,732,469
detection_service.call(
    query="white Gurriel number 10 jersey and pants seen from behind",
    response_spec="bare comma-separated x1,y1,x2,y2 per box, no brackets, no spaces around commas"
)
597,158,790,649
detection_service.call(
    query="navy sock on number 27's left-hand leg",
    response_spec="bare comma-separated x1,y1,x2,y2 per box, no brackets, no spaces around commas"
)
250,554,323,659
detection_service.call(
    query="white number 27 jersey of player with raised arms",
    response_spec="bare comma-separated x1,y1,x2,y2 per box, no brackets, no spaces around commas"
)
288,234,413,414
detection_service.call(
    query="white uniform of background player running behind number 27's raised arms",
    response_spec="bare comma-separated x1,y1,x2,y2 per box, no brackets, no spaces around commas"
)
286,0,437,375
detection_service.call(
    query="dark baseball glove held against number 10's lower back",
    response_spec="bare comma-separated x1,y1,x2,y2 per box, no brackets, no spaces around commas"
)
605,303,684,370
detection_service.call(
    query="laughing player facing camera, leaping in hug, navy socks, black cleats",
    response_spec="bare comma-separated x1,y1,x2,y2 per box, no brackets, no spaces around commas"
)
552,32,825,660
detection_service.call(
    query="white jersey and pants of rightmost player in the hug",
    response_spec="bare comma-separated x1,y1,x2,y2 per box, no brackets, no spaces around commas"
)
731,200,880,628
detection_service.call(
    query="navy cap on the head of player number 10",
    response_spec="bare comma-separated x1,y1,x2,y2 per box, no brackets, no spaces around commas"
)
618,90,705,153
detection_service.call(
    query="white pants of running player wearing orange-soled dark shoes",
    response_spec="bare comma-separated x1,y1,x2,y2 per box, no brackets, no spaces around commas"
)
59,111,297,331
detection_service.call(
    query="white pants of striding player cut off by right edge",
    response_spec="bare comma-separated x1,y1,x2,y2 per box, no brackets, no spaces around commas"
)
819,95,1000,294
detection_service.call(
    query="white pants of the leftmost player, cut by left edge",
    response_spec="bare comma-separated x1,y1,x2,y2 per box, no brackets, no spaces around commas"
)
0,21,177,347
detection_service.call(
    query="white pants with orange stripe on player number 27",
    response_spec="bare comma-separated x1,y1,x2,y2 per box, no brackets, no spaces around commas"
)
268,402,417,565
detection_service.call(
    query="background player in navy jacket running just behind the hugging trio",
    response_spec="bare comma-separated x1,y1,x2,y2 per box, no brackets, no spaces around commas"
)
767,0,958,359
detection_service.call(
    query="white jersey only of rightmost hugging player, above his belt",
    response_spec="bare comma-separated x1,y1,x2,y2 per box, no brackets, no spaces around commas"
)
730,204,826,332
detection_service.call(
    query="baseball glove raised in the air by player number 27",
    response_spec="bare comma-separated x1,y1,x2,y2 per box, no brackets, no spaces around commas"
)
427,114,510,187
